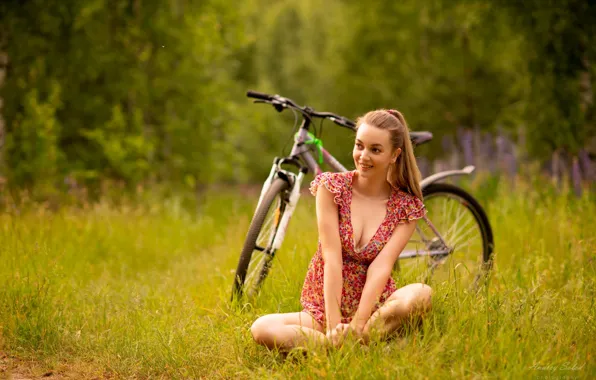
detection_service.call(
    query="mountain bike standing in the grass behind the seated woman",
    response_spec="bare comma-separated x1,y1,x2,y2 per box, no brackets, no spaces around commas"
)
232,91,494,301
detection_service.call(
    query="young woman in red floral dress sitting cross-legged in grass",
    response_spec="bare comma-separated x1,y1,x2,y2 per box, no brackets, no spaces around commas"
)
251,110,432,351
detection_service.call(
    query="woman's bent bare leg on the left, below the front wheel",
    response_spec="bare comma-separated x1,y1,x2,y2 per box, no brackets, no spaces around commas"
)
250,311,328,351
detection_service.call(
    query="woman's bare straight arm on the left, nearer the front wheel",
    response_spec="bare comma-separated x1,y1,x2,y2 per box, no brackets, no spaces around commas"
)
316,186,343,331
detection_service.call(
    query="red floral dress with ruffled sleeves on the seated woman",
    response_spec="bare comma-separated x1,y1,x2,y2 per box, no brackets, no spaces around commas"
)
300,170,426,327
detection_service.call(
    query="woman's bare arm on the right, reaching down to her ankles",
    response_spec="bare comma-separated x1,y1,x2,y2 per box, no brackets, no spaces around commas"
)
350,221,416,333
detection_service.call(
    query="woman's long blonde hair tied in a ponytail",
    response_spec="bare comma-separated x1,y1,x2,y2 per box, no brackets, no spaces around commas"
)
356,109,422,200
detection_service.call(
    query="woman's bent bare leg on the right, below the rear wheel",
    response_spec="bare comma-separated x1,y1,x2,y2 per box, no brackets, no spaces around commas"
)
363,283,432,343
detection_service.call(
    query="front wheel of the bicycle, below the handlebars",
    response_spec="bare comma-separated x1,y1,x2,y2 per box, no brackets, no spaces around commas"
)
232,178,289,301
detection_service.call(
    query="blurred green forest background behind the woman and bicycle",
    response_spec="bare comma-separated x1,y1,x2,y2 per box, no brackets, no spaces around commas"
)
0,0,596,202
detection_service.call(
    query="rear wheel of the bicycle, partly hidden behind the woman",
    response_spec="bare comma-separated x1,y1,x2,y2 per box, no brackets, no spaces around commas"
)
396,183,494,289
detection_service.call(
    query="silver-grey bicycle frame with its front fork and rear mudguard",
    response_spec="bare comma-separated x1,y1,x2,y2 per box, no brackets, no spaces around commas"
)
257,118,475,259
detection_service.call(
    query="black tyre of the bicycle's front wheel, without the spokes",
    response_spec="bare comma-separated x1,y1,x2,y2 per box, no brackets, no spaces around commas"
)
231,178,290,301
